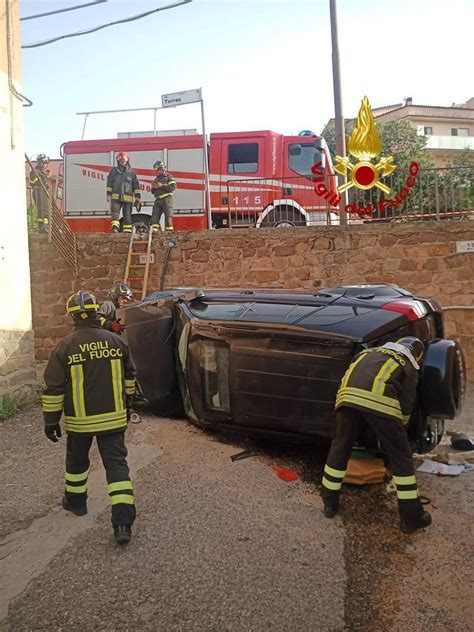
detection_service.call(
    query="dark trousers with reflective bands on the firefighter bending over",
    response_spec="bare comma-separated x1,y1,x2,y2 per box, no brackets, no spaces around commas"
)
321,406,422,517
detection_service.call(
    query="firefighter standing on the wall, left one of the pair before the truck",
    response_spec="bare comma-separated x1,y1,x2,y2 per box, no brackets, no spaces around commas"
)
107,151,141,233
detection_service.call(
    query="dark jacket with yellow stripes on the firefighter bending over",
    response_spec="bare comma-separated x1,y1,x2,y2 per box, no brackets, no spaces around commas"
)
336,347,418,423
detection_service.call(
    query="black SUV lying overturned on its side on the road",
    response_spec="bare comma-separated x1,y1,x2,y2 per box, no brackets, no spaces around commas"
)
121,285,466,452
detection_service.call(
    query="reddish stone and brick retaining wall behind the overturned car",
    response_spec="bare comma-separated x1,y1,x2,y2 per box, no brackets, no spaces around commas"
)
30,221,474,390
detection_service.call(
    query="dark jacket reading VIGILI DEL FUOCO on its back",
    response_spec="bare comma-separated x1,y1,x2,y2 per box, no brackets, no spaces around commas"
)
42,319,136,435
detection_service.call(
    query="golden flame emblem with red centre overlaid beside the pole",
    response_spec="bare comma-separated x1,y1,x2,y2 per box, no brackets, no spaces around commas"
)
334,97,396,195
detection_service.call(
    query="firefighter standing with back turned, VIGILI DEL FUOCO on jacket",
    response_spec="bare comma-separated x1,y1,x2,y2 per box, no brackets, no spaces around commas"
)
42,291,135,543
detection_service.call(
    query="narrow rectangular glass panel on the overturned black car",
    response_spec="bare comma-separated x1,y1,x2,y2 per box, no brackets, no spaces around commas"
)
200,340,230,412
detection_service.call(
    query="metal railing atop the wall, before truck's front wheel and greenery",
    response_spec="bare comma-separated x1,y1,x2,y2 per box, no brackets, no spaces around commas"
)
225,165,474,228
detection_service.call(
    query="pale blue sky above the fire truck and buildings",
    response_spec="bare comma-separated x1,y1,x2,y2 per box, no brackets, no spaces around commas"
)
20,0,474,158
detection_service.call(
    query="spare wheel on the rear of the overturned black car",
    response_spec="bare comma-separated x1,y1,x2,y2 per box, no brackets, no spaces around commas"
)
420,340,466,419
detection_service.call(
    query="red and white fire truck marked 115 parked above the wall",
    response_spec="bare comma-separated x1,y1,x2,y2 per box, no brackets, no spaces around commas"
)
62,131,338,232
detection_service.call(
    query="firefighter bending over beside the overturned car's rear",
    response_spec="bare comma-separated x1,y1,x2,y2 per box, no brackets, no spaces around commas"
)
321,336,431,533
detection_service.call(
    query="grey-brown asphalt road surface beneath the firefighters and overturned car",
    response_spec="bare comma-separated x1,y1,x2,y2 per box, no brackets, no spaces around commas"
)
0,406,474,632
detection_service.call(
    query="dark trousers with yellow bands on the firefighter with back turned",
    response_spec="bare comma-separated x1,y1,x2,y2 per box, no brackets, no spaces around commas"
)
65,432,135,527
